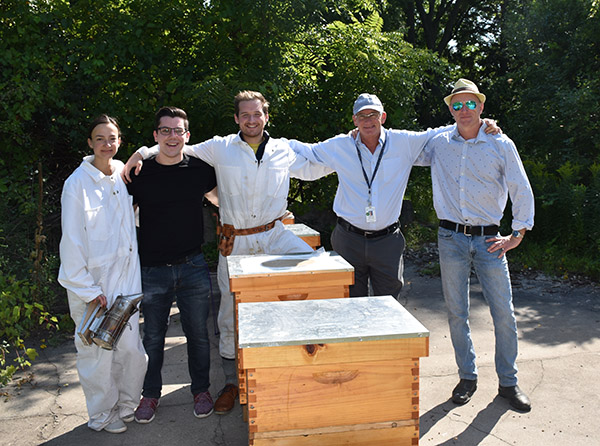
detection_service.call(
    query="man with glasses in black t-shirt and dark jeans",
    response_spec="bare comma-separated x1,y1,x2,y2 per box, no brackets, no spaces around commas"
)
127,107,216,423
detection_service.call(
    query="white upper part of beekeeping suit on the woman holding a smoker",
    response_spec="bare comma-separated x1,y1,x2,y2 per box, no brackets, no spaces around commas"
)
58,156,141,307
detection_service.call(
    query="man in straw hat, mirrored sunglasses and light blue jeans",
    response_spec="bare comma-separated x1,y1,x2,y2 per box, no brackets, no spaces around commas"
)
417,79,534,412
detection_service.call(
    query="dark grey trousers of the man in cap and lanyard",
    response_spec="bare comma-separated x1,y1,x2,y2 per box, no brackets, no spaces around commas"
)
331,221,405,299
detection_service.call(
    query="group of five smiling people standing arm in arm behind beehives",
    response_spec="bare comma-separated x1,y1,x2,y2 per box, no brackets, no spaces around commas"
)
59,79,534,433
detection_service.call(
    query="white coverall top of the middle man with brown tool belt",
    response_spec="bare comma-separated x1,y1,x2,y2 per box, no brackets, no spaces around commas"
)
138,133,332,229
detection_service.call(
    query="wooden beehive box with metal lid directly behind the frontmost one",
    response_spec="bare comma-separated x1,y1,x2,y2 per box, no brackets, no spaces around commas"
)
227,250,354,404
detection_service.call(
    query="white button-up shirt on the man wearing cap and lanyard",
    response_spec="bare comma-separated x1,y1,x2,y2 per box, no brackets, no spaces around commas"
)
292,127,446,231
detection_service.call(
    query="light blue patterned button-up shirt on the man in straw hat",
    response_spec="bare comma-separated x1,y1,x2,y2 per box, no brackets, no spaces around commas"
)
417,124,535,230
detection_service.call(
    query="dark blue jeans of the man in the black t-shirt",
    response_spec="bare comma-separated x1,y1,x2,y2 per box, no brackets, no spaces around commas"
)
141,254,210,398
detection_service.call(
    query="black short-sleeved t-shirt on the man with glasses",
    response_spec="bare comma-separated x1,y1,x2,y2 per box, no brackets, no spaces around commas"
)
127,155,217,266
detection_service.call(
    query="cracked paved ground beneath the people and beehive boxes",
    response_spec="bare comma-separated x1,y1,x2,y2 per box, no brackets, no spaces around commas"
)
0,267,600,446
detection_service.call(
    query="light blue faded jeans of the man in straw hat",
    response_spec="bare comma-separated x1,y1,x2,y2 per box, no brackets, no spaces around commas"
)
438,228,518,386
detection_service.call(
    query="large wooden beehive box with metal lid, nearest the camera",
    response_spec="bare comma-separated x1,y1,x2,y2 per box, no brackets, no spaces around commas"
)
238,296,429,446
